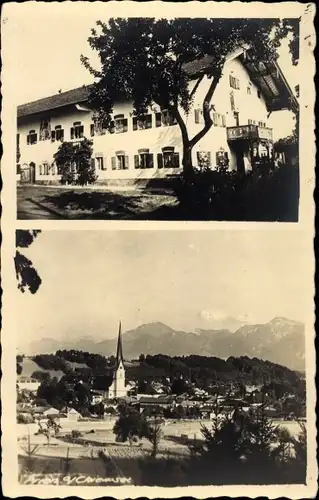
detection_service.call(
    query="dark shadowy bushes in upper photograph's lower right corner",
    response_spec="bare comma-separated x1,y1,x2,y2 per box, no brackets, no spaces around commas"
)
175,164,299,222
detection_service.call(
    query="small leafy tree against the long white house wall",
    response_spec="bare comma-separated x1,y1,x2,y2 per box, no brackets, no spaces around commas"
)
54,138,97,186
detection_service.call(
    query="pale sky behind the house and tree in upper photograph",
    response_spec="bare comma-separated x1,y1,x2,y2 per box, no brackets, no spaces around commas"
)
7,2,299,139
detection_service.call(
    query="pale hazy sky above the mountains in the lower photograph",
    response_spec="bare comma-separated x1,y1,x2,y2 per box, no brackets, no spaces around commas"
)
15,229,309,346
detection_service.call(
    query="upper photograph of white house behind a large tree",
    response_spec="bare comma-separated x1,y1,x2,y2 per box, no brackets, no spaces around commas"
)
14,15,300,222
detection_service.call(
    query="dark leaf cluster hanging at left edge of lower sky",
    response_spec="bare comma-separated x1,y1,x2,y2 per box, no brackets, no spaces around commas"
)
14,229,41,294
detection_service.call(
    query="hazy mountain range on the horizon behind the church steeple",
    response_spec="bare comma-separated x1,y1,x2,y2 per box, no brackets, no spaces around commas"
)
21,317,305,371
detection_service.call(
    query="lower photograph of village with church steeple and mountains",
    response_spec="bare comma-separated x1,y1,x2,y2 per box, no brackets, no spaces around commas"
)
14,229,312,488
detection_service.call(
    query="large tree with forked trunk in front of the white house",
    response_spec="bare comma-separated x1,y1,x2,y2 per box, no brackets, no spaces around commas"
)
81,18,299,180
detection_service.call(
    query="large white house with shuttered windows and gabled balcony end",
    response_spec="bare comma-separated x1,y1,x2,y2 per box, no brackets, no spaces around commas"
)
17,48,298,185
